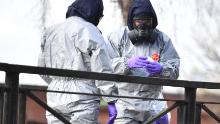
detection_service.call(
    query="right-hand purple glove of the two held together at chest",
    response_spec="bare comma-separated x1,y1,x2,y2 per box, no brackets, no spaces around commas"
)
145,61,163,75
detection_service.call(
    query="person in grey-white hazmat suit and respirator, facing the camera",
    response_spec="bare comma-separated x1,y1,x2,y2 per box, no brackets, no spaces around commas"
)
107,0,180,124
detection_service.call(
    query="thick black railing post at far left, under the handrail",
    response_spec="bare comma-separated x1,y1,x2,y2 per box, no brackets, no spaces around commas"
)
3,72,19,124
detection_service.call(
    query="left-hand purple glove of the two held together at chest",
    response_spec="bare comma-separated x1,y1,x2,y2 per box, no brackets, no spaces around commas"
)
127,56,147,68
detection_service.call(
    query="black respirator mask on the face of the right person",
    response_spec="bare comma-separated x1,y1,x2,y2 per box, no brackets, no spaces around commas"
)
128,17,154,44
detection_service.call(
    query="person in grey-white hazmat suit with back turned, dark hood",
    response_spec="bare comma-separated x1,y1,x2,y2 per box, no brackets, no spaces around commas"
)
38,0,115,124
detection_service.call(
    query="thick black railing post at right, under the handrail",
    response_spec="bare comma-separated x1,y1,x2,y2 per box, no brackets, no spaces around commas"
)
185,87,196,124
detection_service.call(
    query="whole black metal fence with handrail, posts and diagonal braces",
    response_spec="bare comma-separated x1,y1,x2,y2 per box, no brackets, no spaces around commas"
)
0,63,220,124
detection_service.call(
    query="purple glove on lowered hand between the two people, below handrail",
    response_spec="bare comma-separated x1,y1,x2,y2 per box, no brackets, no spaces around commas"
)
107,103,117,124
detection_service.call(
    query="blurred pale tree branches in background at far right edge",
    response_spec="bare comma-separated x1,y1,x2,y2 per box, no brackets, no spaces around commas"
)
192,0,220,81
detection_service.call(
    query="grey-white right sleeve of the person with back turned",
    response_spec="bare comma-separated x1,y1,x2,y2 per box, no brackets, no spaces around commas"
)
81,25,117,102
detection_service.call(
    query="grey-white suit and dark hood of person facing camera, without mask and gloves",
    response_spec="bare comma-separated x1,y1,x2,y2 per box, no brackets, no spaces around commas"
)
107,0,180,124
